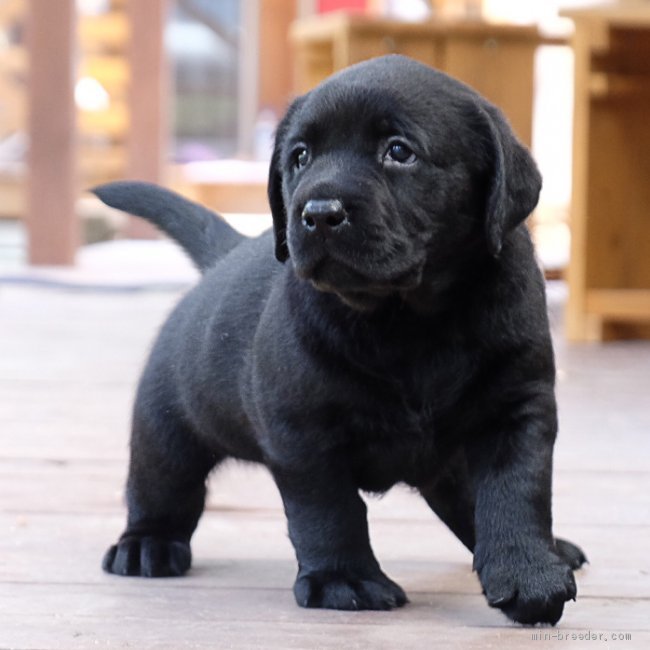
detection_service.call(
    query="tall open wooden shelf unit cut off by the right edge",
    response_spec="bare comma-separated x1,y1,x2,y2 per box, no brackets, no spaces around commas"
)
564,2,650,340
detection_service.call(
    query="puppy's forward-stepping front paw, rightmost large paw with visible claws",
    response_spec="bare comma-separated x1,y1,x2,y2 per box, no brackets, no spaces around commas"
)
477,548,576,625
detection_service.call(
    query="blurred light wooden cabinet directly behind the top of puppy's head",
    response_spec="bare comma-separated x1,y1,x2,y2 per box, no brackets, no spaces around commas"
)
291,13,555,144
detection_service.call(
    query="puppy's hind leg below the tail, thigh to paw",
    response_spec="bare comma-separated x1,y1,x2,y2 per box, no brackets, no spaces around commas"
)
102,400,221,577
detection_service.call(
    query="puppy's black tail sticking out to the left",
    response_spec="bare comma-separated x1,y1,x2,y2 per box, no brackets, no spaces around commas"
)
91,181,245,272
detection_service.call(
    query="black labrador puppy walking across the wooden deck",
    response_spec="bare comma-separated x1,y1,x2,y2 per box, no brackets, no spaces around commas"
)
95,56,585,623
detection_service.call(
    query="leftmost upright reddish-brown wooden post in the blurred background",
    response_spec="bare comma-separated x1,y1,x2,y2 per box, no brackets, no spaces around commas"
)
26,0,80,264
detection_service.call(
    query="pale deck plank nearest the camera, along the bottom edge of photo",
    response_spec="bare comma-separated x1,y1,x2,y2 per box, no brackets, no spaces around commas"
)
0,604,650,650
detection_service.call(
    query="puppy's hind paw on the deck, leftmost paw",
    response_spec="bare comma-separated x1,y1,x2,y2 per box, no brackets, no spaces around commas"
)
102,535,192,578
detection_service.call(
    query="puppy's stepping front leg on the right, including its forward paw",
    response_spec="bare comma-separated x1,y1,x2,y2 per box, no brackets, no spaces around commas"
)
470,396,576,624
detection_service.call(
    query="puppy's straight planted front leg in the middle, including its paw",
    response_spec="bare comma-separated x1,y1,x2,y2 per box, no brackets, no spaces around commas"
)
273,468,407,610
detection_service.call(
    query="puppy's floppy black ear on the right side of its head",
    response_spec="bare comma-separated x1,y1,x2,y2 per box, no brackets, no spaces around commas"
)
482,104,542,257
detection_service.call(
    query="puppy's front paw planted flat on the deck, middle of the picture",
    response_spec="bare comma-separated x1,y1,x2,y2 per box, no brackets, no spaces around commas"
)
293,571,408,610
